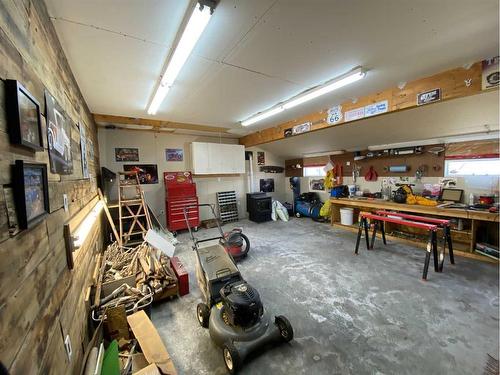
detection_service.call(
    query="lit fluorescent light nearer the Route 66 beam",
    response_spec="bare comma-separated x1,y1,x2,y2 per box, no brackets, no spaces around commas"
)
241,67,366,126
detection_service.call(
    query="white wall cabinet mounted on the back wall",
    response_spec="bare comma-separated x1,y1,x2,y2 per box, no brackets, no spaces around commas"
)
191,142,245,174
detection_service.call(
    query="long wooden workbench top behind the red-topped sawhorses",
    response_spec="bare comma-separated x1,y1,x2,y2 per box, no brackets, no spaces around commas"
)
330,198,499,222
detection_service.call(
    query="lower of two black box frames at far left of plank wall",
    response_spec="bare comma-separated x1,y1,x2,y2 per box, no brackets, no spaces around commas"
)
12,160,49,229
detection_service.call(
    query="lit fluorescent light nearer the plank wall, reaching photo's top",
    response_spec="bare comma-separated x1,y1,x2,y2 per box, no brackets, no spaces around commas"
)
148,3,213,115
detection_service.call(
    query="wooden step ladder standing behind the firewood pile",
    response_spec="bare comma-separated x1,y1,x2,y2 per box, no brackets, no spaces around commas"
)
118,171,152,247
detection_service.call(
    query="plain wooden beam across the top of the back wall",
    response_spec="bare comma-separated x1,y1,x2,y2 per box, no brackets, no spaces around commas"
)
93,113,230,133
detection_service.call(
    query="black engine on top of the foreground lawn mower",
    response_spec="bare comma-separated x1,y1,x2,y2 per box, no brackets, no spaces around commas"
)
220,281,264,327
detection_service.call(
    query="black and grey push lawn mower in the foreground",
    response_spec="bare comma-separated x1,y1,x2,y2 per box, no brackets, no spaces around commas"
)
184,204,293,374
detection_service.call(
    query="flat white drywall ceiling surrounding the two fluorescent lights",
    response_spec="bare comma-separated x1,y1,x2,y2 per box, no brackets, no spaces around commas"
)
45,0,499,132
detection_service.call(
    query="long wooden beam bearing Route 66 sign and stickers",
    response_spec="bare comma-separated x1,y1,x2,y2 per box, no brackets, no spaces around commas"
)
240,61,494,147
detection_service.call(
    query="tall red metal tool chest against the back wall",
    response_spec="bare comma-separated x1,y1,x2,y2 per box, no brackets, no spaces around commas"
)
163,172,200,232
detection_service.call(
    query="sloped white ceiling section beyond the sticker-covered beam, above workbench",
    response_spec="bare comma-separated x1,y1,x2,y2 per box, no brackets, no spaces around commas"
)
259,91,499,158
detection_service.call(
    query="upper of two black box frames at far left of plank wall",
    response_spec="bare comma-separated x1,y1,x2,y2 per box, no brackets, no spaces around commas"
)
5,79,43,152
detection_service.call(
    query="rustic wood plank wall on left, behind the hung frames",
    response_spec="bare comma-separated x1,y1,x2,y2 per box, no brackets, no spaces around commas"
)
0,0,103,374
